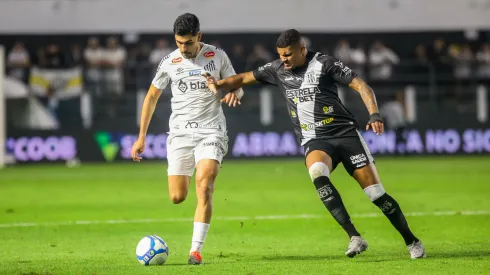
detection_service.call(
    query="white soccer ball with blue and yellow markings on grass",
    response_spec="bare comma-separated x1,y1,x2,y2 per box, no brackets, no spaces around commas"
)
136,235,168,265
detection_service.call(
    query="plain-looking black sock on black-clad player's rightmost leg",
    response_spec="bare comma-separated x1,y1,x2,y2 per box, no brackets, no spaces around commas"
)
373,193,418,245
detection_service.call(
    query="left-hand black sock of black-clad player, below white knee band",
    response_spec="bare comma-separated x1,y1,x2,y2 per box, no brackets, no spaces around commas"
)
313,176,361,238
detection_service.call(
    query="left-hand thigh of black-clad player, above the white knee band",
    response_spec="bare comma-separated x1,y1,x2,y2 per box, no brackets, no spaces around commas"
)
304,139,339,171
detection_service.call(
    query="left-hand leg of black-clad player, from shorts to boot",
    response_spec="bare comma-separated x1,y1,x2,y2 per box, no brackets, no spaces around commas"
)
305,141,367,257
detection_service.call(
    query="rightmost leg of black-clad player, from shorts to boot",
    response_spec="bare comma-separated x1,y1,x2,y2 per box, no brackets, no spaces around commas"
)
342,132,425,258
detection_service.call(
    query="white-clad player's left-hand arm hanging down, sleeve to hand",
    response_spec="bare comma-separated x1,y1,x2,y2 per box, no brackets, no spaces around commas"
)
131,58,170,162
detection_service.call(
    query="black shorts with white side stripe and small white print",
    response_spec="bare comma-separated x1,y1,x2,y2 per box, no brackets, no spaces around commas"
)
304,130,374,175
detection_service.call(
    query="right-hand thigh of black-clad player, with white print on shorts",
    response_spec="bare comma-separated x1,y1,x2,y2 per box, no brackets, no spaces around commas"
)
339,130,379,188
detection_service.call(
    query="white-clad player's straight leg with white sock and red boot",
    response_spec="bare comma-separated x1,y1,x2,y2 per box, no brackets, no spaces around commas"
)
189,135,228,264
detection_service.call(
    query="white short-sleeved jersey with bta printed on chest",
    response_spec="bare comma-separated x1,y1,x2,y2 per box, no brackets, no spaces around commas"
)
152,43,240,133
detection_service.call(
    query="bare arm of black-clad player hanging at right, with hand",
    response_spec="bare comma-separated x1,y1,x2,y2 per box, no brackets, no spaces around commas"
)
349,76,384,135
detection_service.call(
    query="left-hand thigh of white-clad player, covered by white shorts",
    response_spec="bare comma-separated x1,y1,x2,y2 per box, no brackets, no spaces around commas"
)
167,134,196,177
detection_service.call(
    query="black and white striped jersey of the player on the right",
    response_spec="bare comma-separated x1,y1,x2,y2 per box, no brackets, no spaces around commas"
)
253,52,358,145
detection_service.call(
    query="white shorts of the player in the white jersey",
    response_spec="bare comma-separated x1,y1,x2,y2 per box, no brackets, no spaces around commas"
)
167,133,228,177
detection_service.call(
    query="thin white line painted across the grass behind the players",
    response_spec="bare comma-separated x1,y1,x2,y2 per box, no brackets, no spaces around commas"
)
0,210,490,228
